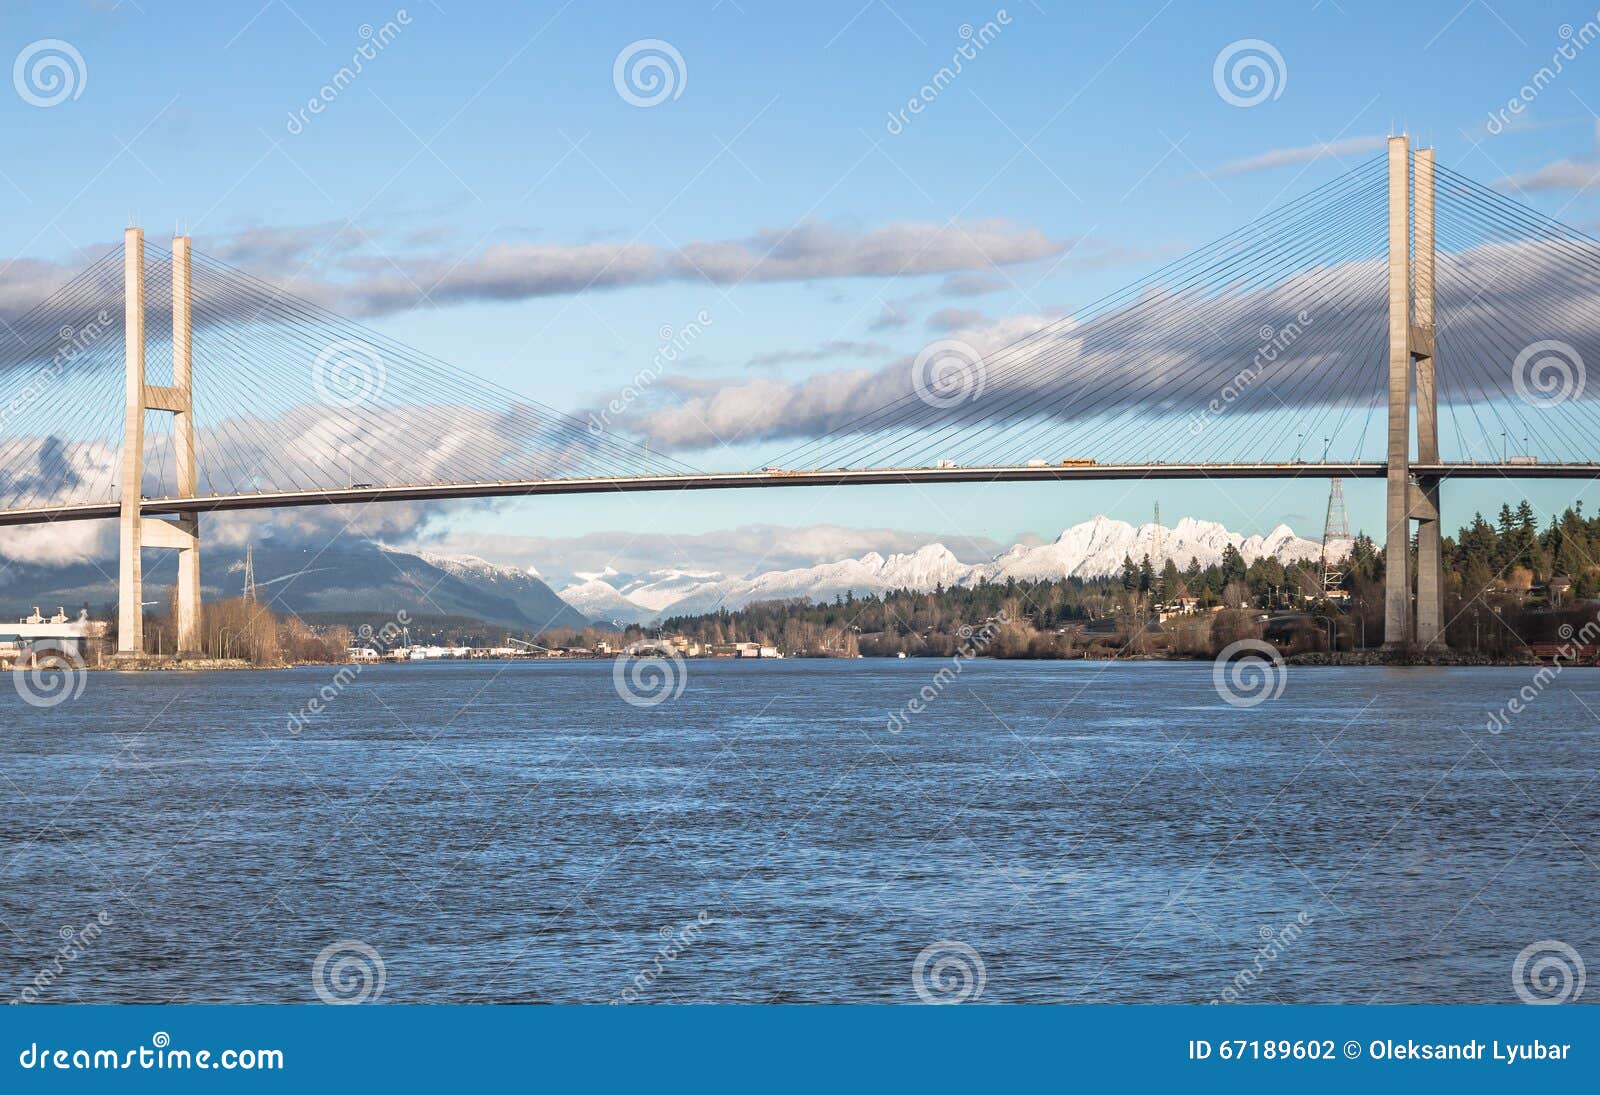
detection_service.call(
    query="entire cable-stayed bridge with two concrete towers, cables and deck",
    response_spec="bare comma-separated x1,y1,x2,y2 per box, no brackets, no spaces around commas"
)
0,138,1600,655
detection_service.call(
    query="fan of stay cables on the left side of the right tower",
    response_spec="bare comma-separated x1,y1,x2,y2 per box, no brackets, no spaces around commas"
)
776,157,1387,467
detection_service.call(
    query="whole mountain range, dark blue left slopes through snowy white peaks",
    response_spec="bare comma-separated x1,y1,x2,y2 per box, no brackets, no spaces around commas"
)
0,517,1350,632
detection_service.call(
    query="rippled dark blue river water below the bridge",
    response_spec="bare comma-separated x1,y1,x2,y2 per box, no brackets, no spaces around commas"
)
0,660,1600,1004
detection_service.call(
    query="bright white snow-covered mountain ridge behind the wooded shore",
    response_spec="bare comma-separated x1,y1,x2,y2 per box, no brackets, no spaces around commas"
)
562,517,1350,623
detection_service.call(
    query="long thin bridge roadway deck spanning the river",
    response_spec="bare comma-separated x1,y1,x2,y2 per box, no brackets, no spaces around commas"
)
0,463,1600,525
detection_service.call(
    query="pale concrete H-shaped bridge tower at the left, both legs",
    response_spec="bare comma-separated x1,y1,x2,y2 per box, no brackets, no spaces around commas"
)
117,229,200,656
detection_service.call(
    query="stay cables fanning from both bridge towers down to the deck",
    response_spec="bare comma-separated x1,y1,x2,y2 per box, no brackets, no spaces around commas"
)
0,157,1600,509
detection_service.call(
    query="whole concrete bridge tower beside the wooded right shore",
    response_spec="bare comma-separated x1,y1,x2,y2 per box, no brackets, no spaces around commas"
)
1384,136,1445,650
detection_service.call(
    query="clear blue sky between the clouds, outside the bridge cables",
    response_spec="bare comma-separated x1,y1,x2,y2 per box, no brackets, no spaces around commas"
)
0,0,1600,576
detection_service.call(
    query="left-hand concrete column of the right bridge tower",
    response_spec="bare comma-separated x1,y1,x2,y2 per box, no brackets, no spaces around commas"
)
1384,136,1411,650
